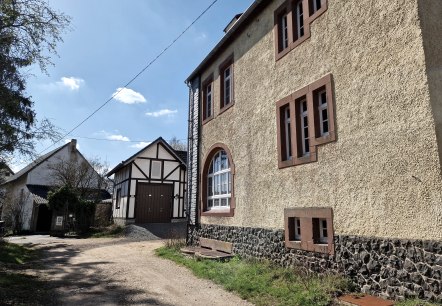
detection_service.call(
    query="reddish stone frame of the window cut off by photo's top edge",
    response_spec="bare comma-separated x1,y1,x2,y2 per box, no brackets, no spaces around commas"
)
273,0,328,61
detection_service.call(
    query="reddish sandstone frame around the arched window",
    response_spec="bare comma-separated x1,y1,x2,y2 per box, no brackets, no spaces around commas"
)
200,143,236,217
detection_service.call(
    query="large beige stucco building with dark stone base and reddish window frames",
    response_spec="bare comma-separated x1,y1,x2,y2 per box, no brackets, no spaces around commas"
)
187,0,442,301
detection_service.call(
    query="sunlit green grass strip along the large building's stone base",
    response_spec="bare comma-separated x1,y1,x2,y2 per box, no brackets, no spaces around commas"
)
156,247,351,306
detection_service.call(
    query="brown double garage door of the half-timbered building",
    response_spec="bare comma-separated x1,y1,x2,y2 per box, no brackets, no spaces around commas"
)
135,183,173,223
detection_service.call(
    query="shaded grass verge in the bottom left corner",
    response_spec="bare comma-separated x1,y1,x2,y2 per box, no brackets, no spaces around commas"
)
0,241,57,305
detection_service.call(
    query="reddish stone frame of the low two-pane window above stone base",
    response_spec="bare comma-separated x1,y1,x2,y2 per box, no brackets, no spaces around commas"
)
284,207,335,255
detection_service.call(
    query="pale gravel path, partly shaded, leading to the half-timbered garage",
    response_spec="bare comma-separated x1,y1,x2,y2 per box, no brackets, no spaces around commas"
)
10,236,251,306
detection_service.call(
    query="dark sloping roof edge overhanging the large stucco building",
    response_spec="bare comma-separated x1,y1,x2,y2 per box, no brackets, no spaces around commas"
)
185,0,272,84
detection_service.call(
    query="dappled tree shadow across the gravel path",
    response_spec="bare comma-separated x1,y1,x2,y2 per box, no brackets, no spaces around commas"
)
21,243,173,306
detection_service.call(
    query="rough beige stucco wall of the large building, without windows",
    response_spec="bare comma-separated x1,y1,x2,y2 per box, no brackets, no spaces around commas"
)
201,0,442,239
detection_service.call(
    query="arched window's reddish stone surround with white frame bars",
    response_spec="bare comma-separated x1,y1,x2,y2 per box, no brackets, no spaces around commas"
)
200,143,235,217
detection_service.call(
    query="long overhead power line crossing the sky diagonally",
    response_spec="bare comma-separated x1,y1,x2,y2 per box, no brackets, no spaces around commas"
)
38,0,218,155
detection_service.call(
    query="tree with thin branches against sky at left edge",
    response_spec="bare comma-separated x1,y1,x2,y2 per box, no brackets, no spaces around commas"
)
0,0,70,162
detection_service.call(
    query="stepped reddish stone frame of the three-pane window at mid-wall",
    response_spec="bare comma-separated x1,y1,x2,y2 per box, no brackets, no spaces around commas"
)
276,74,336,169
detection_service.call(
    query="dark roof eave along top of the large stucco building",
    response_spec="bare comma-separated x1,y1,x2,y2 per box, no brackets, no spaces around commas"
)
186,0,272,83
